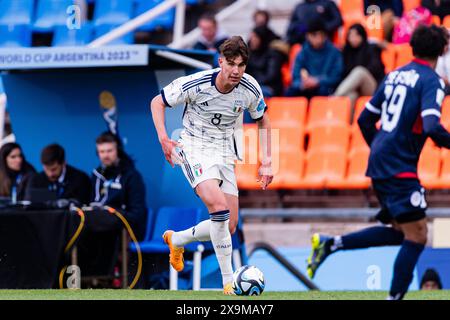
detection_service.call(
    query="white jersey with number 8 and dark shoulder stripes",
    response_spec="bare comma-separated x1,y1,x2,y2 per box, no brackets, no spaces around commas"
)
161,68,266,159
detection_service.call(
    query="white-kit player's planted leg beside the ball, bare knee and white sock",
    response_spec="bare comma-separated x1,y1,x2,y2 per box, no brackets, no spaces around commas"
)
196,180,233,294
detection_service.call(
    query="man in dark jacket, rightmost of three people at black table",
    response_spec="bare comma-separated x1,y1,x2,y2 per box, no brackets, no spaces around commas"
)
92,132,147,238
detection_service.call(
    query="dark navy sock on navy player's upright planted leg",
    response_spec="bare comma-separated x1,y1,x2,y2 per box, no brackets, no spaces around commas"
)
389,240,425,300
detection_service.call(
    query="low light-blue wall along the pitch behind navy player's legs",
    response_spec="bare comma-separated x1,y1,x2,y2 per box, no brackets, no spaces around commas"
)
249,247,450,291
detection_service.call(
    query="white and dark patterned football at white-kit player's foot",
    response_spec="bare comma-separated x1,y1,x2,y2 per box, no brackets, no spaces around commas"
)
233,266,265,296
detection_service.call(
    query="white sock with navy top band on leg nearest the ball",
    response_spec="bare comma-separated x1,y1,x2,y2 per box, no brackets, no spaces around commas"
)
210,210,233,285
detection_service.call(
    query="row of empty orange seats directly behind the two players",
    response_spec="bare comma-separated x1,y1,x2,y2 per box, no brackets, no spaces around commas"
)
236,97,450,190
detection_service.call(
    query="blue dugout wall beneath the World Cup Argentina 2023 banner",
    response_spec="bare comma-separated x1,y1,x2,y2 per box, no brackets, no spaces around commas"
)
3,49,214,210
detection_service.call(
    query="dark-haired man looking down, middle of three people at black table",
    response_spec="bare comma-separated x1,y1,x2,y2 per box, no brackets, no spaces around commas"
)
28,144,92,205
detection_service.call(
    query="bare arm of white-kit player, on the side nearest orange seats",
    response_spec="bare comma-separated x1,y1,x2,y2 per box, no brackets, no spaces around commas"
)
257,113,273,190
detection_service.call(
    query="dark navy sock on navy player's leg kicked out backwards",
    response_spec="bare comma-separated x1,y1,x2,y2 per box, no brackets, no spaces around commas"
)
327,226,404,252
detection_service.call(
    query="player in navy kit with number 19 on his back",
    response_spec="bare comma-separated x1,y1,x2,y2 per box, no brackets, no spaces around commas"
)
307,26,450,300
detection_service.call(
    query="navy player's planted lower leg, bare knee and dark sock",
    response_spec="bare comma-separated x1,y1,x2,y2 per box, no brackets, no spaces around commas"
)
389,218,428,300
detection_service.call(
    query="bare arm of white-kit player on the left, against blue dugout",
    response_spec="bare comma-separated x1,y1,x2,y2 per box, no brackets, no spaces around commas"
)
150,94,179,168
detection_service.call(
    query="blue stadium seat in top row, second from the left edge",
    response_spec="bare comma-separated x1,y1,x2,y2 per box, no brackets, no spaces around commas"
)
34,0,74,32
